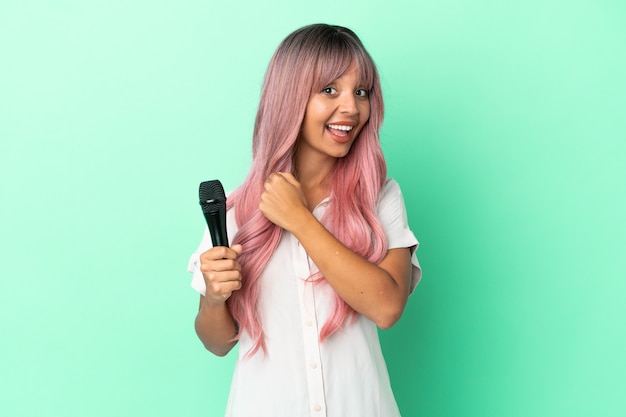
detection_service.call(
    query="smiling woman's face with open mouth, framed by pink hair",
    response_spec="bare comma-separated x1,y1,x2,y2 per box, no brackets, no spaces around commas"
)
298,65,370,158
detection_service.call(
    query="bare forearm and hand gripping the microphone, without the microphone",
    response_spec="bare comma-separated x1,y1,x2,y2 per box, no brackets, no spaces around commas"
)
195,245,241,356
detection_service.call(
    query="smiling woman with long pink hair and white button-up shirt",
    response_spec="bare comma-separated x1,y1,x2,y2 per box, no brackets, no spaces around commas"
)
189,24,421,417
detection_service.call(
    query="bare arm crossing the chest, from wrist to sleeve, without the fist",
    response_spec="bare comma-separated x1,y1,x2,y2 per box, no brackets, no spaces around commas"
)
291,214,411,328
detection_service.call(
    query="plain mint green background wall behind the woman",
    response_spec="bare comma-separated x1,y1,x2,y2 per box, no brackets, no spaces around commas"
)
0,0,626,417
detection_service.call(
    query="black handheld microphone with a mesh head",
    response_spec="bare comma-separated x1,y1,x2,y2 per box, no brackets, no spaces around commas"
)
199,180,228,246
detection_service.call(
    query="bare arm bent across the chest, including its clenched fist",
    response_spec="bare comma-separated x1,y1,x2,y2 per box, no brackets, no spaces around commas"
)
259,173,411,329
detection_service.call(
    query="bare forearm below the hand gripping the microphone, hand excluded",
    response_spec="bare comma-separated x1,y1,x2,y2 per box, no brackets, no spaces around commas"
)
195,297,237,356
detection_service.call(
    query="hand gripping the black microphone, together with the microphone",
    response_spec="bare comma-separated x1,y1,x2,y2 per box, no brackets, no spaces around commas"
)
199,180,242,306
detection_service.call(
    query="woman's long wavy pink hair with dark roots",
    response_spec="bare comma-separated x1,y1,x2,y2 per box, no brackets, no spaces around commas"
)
228,24,387,355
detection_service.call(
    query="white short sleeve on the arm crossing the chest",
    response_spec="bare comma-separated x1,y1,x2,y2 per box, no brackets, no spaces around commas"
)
378,178,422,292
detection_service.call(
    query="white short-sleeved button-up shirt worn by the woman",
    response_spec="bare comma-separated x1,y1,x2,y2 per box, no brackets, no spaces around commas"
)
188,179,421,417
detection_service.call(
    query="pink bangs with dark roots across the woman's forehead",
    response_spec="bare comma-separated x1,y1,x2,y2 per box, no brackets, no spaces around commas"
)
311,36,376,91
